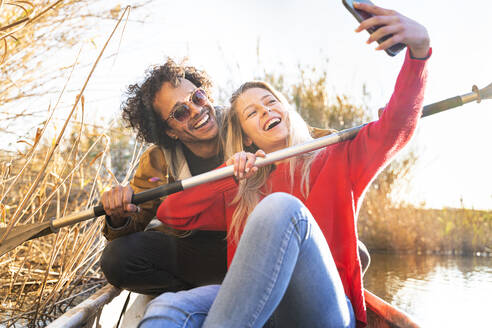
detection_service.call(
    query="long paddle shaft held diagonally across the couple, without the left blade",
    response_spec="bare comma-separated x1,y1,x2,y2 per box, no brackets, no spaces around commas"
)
51,84,486,232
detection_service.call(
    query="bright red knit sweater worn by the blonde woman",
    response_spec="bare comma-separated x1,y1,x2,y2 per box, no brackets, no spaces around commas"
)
157,51,427,326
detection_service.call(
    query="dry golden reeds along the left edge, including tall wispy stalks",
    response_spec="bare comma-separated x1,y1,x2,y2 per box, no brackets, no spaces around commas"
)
0,1,140,327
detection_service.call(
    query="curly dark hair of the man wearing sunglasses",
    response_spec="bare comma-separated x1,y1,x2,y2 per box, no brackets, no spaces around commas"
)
121,58,212,148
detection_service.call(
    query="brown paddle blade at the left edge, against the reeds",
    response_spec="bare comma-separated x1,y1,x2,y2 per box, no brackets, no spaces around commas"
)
0,221,53,256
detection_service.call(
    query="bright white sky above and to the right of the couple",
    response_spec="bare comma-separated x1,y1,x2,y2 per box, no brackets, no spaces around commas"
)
4,0,492,209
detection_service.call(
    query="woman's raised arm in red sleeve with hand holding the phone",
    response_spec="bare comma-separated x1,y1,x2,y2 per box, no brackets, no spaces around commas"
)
347,4,431,193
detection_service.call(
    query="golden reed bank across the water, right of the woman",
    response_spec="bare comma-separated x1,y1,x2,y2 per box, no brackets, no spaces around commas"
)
359,202,492,255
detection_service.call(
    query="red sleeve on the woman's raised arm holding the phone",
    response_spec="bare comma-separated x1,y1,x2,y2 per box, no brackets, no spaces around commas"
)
348,49,432,195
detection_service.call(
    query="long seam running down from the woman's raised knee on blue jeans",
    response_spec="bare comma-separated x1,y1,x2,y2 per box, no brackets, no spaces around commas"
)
248,210,305,327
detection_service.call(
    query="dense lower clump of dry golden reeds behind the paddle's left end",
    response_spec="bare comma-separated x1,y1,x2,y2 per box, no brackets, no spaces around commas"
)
0,131,111,326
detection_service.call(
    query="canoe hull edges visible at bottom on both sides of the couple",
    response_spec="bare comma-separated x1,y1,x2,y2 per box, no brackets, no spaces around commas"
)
48,284,420,328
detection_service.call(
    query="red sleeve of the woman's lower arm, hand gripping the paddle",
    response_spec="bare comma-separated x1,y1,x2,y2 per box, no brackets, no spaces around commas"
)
157,166,237,231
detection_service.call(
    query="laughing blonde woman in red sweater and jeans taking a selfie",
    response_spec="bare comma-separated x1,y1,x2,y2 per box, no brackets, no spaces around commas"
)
141,5,430,328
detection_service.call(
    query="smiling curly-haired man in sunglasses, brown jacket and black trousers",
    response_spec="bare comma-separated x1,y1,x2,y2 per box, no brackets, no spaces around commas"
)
101,59,226,295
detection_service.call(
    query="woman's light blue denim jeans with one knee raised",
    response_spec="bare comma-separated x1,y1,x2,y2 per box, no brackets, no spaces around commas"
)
139,193,355,328
